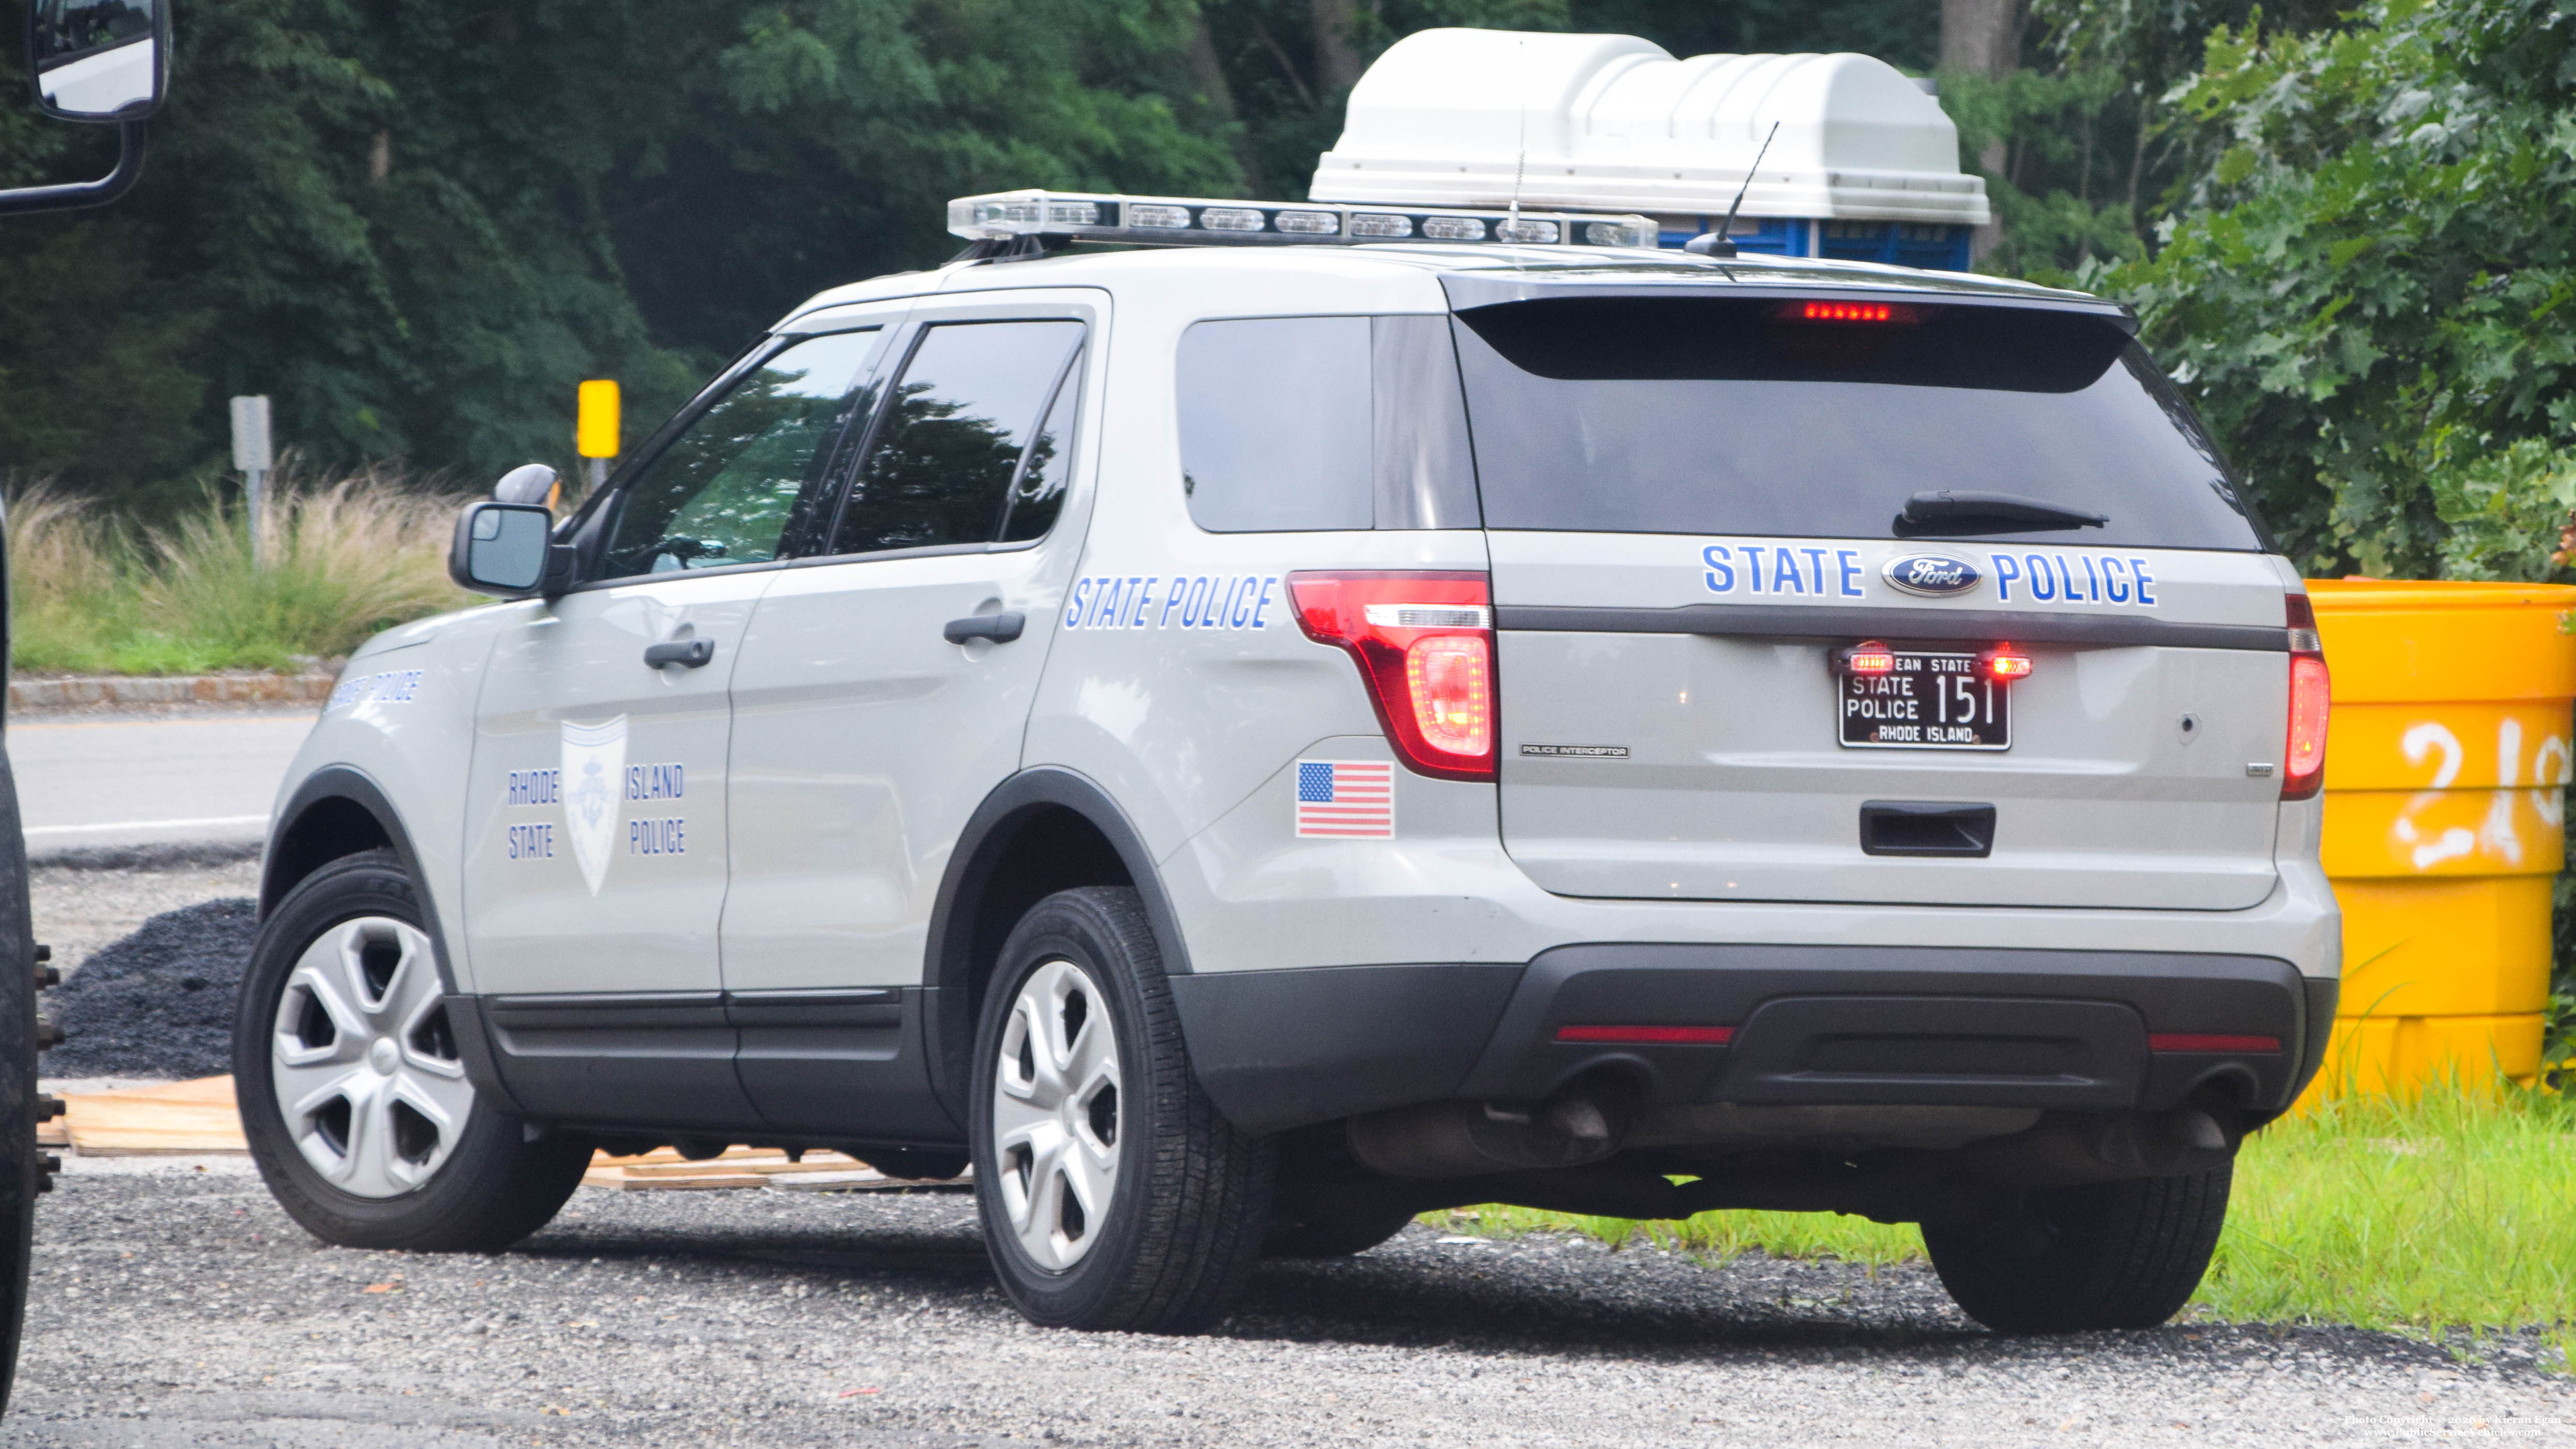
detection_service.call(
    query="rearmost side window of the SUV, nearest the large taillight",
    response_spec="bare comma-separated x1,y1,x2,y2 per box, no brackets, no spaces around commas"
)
1180,316,1476,533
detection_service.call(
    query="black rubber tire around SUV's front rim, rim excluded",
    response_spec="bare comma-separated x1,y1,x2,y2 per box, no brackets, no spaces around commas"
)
232,849,590,1254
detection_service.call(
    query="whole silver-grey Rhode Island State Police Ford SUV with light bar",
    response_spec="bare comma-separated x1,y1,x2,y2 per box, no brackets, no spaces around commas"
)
237,193,2339,1331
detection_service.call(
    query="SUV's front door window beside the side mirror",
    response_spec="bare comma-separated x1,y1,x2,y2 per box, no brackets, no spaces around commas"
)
595,329,878,579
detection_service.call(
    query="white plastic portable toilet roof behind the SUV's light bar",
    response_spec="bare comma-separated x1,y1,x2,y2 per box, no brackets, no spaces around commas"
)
1311,28,1991,226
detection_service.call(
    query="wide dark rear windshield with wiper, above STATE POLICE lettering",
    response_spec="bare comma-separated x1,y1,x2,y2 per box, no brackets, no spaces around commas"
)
1455,296,2264,548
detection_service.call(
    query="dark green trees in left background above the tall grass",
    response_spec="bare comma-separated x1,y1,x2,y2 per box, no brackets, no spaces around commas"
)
0,0,1237,507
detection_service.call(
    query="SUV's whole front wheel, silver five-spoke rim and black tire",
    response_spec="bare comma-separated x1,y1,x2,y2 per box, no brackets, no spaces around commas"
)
232,849,590,1254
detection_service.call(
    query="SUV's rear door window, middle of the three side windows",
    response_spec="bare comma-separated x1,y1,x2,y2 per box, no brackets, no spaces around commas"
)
832,319,1082,553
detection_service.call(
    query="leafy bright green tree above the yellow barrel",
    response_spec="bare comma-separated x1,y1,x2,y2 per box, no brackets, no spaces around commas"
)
2086,0,2576,579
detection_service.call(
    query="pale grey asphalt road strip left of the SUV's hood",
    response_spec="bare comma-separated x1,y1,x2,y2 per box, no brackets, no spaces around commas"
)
8,710,314,860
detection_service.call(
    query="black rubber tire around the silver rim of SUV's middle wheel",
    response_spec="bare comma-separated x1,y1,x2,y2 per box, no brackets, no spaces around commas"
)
971,886,1278,1333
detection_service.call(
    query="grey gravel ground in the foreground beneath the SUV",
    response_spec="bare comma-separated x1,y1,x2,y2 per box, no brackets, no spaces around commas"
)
0,1163,2576,1449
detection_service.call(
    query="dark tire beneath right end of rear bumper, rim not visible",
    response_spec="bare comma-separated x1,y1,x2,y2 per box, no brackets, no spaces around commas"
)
1924,1166,2233,1333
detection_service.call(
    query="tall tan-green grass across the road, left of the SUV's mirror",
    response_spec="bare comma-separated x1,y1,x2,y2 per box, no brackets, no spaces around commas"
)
8,468,471,674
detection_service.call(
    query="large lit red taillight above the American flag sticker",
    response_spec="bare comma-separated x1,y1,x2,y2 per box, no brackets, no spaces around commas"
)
1288,574,1494,780
